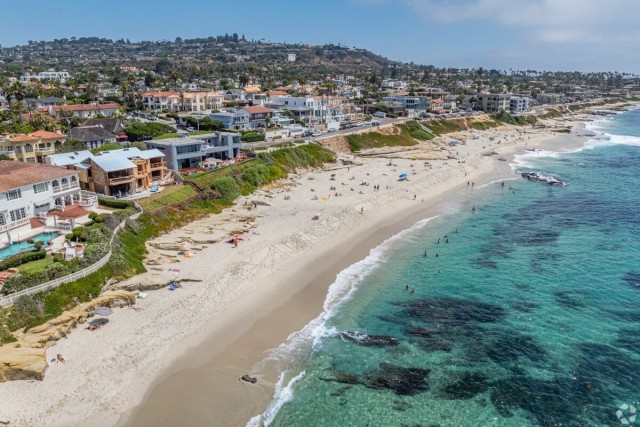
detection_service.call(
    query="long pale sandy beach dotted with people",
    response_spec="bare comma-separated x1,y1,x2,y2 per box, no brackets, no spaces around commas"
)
0,112,608,426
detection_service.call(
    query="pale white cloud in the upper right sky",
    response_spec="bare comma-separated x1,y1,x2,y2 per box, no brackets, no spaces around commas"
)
403,0,640,43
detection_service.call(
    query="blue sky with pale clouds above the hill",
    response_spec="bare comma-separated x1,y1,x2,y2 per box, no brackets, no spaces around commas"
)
0,0,640,73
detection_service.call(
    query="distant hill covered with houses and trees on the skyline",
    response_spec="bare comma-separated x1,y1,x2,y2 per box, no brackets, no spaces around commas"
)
0,34,402,78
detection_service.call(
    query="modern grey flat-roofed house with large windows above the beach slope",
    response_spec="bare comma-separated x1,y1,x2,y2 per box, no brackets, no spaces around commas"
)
146,135,241,172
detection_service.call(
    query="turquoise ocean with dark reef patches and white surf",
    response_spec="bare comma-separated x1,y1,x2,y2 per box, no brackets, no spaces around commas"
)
249,109,640,427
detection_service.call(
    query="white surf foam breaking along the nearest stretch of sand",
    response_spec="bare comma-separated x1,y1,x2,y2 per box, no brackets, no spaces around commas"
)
247,215,439,427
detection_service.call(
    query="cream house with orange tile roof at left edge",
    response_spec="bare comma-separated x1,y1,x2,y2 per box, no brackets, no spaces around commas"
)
0,130,68,163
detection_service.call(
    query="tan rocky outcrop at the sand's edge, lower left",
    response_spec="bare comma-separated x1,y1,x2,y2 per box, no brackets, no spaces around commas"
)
0,291,136,382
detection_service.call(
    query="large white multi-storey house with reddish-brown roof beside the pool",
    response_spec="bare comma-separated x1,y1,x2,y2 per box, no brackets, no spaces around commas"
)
0,160,82,240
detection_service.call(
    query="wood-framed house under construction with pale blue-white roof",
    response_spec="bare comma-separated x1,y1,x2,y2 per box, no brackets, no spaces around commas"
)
45,147,169,196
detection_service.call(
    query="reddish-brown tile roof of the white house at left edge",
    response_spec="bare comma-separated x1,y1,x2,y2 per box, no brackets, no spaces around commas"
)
0,160,74,193
